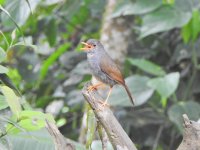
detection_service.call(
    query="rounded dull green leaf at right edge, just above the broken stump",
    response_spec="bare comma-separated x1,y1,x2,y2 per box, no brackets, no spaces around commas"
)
168,101,200,132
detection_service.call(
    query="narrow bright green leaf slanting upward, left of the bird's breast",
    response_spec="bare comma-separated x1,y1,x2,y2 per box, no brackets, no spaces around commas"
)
40,43,71,79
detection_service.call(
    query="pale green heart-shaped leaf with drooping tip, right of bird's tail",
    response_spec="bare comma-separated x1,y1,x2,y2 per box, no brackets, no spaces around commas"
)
147,72,180,99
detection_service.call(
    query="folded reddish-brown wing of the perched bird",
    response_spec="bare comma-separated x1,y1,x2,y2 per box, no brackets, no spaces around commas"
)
100,54,125,85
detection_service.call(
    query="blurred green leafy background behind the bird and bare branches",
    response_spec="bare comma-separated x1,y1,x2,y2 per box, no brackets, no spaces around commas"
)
0,0,200,150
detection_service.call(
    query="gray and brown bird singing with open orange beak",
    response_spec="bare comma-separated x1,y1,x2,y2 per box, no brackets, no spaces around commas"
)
81,39,134,106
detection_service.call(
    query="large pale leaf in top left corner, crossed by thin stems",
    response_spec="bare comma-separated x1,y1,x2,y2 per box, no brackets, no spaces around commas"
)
1,0,41,29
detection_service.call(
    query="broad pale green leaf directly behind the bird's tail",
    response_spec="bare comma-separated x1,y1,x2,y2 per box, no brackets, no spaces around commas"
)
109,75,154,107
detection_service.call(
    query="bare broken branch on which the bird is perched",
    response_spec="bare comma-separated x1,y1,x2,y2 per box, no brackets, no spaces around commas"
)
82,83,137,150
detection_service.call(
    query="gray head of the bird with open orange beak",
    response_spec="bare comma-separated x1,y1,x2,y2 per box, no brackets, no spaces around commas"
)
81,39,104,53
